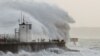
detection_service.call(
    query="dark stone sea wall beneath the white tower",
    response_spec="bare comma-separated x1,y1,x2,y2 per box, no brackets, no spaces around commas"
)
0,42,65,53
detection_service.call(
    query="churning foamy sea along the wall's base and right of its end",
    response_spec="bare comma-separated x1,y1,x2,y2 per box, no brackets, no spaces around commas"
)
0,39,100,56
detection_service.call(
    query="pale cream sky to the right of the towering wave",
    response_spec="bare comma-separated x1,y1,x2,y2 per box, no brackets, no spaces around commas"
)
46,0,100,27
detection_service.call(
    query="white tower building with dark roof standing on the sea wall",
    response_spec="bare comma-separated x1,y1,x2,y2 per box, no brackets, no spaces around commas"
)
19,18,32,42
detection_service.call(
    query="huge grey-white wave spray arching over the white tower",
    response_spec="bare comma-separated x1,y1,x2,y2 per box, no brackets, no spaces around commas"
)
0,0,74,40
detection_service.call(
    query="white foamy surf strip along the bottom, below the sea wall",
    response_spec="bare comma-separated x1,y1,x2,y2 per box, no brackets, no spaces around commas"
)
0,48,100,56
